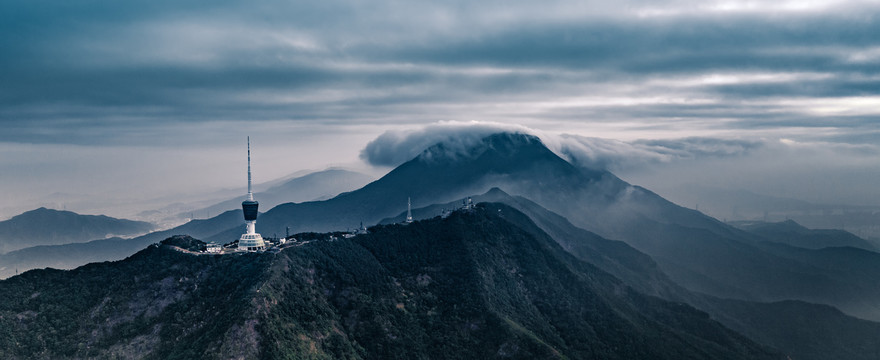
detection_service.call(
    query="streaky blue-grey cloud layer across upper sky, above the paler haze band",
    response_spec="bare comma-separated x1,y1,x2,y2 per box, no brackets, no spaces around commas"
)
0,0,880,144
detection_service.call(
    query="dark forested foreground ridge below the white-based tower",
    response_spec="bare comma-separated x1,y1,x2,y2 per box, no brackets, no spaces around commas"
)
0,206,784,359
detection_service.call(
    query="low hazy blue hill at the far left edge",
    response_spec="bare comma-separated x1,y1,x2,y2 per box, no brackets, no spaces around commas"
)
0,208,154,253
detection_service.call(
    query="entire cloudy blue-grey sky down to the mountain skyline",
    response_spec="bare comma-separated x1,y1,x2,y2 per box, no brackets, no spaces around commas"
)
0,0,880,218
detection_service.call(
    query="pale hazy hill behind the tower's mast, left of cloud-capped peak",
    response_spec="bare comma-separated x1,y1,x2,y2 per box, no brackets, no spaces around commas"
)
183,169,374,216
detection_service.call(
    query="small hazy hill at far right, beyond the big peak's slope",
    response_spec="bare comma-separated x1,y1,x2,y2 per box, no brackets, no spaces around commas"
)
732,220,877,251
